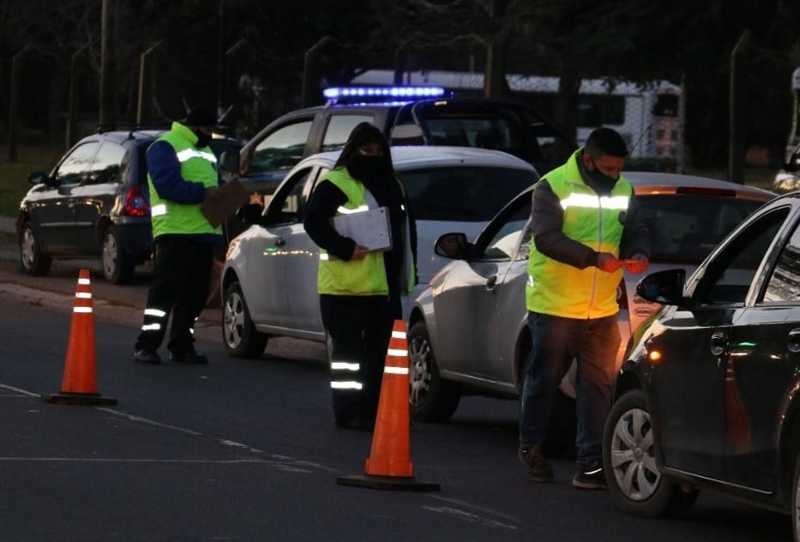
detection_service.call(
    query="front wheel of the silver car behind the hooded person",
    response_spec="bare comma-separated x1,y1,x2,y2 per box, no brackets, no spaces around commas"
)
222,281,267,358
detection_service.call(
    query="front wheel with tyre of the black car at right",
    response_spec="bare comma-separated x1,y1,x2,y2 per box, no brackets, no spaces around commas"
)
603,390,697,517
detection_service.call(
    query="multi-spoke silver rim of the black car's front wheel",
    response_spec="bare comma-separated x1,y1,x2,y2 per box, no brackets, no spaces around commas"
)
611,408,661,501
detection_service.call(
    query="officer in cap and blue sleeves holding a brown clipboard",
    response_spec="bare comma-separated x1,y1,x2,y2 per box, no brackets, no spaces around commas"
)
134,109,223,364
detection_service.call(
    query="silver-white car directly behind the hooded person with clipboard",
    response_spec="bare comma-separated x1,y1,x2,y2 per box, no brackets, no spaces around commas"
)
222,146,539,357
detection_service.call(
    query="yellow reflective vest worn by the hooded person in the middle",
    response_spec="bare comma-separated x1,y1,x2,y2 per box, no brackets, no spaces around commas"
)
317,167,415,295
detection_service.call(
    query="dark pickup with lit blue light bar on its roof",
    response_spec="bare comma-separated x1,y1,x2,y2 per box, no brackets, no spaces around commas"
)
234,87,562,193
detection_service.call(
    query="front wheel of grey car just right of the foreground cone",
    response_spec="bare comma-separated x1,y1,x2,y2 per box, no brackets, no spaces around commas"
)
408,322,461,422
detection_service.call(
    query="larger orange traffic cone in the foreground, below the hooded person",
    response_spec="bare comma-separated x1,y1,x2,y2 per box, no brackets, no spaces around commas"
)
337,320,440,491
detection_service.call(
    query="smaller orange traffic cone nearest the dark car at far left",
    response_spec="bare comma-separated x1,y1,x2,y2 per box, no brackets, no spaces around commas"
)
44,269,117,405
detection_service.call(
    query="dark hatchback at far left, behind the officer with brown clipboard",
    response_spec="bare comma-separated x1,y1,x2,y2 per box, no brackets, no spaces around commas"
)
17,131,161,283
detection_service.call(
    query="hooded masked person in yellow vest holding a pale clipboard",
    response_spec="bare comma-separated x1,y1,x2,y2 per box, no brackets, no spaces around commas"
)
304,122,416,428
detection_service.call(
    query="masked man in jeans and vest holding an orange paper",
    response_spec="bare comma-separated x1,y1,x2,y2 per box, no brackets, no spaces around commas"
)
518,128,649,489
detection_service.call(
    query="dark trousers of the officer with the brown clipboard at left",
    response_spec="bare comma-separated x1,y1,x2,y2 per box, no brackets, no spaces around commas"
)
136,235,214,353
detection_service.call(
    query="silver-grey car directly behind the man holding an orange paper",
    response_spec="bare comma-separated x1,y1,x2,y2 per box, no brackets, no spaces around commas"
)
408,172,774,421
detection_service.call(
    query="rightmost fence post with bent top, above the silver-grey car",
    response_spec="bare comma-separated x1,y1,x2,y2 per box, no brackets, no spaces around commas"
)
728,30,750,183
